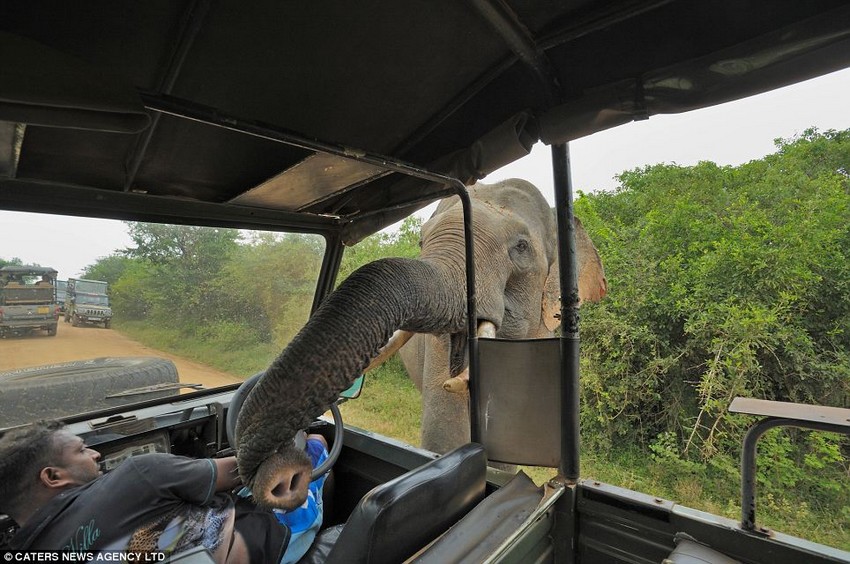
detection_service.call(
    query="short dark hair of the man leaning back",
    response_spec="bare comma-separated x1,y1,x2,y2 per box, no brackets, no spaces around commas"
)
0,421,65,513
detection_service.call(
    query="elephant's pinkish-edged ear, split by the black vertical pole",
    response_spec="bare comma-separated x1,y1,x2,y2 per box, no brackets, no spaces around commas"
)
542,217,608,331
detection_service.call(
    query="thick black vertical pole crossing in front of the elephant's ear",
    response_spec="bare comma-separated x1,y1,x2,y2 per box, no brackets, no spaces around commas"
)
552,144,580,482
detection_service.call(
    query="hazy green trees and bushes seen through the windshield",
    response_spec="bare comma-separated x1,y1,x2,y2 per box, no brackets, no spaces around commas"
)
85,223,324,375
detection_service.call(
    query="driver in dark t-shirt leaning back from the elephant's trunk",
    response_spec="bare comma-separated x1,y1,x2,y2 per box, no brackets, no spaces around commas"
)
0,421,327,564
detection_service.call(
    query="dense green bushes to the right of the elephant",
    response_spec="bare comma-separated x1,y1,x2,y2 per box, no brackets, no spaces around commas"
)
576,130,850,524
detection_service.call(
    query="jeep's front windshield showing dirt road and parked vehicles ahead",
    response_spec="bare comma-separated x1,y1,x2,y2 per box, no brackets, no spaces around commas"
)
0,212,325,428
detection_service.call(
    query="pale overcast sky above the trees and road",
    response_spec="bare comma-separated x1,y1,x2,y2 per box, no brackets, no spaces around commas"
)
0,65,850,278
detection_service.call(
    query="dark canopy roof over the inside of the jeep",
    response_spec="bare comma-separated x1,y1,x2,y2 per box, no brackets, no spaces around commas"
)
0,0,850,238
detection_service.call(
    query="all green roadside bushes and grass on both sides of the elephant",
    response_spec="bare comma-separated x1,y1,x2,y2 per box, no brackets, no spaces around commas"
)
78,126,850,549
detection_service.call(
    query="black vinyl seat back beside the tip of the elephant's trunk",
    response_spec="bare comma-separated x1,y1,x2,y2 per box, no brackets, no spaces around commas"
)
301,443,487,564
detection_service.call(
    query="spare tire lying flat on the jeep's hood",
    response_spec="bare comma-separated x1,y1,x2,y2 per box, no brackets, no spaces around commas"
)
0,357,179,428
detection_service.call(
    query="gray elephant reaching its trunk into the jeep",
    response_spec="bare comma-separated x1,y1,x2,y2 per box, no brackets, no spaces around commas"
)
236,179,607,509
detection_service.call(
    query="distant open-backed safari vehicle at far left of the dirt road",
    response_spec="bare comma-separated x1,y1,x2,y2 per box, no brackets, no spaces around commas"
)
0,266,59,337
